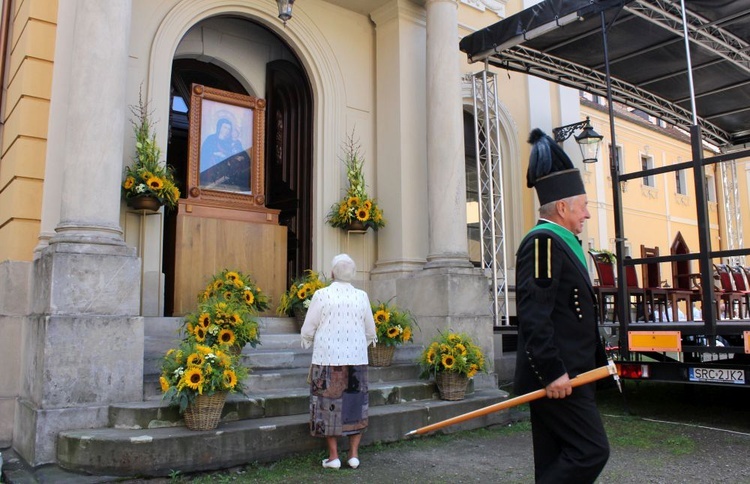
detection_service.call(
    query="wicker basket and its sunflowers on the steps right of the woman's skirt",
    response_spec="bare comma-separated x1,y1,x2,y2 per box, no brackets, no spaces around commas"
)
419,332,487,400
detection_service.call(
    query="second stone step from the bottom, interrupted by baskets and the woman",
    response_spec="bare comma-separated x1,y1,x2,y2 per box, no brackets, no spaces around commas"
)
114,380,456,429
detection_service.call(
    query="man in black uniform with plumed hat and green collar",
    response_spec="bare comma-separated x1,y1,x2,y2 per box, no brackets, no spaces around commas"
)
514,129,609,484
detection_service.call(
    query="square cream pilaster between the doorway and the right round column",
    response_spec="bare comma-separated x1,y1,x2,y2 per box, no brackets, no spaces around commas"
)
370,0,428,301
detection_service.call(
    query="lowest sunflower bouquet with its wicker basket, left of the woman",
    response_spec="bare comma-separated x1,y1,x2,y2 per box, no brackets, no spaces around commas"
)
159,339,249,430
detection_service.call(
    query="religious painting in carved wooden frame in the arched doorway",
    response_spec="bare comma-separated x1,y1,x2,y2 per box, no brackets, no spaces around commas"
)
187,84,266,206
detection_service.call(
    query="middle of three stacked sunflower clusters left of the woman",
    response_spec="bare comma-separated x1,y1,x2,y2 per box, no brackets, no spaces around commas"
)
182,296,260,350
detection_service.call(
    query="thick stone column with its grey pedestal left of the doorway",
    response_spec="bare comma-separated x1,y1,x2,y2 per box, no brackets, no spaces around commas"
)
13,0,144,466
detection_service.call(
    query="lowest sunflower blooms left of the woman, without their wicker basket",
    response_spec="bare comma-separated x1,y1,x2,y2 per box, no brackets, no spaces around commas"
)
159,340,249,413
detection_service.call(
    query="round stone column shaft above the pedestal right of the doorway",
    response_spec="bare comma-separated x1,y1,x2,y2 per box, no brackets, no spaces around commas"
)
425,0,472,268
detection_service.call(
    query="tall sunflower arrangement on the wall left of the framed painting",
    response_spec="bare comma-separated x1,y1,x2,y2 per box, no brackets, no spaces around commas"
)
122,91,180,210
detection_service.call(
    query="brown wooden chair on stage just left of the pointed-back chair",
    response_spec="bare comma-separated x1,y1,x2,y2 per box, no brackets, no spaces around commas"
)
641,245,693,321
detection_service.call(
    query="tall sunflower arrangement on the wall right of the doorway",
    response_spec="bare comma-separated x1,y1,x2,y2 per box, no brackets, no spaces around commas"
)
326,133,385,230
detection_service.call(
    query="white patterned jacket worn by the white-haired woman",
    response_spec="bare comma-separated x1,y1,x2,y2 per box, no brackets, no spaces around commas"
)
301,282,377,366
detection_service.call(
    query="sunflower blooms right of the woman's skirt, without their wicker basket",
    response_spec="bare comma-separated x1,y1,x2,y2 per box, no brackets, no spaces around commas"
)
419,332,487,378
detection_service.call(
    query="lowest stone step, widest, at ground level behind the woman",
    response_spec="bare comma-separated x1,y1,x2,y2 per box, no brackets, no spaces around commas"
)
57,389,510,476
